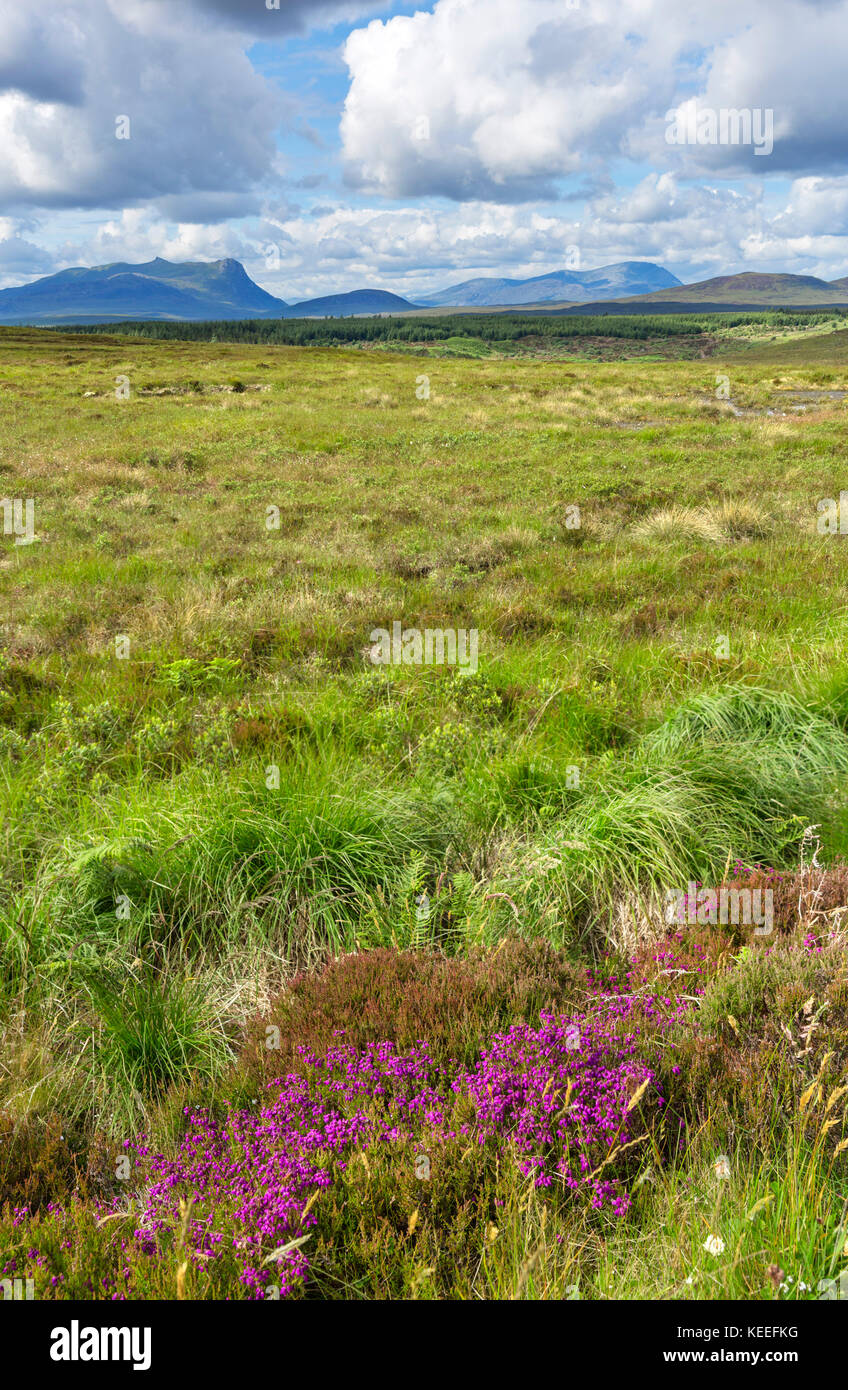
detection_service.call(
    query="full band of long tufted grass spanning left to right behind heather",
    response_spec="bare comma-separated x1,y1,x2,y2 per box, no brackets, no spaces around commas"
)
10,685,848,967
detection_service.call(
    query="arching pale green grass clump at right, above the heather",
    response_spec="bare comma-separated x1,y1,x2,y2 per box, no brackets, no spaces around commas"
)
486,687,848,940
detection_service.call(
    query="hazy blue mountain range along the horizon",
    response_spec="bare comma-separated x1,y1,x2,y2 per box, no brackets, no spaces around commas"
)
0,256,848,325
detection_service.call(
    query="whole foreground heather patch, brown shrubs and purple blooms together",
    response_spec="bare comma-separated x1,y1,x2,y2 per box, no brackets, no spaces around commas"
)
6,924,848,1300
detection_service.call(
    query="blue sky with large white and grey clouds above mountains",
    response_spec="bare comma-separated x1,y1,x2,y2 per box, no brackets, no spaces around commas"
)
0,0,848,302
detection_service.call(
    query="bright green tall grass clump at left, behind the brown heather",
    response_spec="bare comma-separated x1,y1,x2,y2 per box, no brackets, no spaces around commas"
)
15,762,456,965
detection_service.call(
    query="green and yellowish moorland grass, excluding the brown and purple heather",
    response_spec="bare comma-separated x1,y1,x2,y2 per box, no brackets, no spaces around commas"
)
0,322,848,1297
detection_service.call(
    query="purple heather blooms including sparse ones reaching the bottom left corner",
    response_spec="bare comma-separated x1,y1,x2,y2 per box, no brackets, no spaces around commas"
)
0,977,685,1298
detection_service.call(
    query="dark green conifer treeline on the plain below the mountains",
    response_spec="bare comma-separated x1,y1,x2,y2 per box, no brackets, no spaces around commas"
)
60,309,835,346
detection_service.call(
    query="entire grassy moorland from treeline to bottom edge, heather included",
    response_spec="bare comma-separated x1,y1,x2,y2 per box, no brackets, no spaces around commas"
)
0,319,848,1300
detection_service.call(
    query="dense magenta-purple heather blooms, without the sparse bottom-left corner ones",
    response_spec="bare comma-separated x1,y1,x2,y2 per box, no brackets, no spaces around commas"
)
115,988,685,1297
